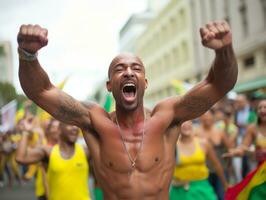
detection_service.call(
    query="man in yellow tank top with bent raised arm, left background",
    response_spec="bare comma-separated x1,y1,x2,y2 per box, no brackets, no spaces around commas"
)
16,117,90,200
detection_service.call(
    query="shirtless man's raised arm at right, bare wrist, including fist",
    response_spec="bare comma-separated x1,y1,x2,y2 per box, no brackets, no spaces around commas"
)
174,21,238,122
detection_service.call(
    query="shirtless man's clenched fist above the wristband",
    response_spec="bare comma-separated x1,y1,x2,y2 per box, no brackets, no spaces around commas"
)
17,24,48,53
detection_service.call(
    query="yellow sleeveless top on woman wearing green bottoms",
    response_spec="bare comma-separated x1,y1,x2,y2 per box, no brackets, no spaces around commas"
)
174,139,209,181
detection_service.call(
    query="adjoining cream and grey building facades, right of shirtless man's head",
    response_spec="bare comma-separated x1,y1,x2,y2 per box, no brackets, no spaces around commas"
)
126,0,266,106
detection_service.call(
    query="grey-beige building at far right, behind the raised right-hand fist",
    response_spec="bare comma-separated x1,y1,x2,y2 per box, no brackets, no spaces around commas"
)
191,0,266,93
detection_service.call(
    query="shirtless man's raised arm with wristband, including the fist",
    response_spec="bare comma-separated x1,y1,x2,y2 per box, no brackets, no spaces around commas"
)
17,25,90,127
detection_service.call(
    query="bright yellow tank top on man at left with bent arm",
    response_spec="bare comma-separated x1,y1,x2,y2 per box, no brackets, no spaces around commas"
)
47,144,90,200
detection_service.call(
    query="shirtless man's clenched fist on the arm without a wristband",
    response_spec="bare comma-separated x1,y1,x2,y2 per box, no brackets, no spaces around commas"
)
200,21,232,50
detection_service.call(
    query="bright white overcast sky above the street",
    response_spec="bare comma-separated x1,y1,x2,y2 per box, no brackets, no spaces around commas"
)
0,0,146,100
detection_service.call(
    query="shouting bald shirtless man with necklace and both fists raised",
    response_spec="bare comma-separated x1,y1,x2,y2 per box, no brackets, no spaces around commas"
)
18,22,237,200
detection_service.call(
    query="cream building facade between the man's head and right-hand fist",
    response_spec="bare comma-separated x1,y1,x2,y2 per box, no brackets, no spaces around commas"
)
136,0,195,106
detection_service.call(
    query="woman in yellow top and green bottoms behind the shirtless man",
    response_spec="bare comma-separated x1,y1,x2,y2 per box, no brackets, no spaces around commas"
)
170,121,227,200
